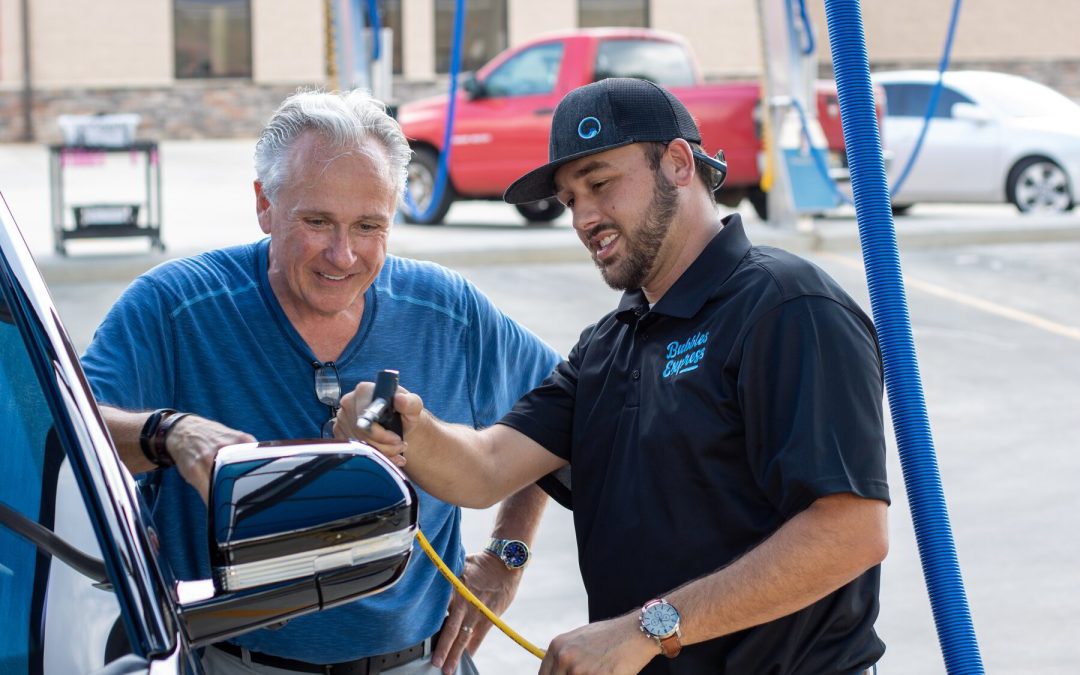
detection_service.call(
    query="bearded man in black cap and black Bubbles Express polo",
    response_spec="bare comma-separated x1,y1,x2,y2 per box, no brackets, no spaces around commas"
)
338,79,889,675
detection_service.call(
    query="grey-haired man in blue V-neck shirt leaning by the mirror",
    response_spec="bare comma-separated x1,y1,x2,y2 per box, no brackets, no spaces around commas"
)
83,92,557,674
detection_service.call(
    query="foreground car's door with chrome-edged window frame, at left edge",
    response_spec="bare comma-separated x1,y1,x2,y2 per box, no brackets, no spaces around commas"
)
0,206,198,675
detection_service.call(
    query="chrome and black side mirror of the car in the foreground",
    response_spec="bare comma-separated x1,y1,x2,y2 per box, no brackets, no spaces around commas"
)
177,440,419,646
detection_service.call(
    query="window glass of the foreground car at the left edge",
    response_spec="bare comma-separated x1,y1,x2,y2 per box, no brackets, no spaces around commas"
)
0,291,130,675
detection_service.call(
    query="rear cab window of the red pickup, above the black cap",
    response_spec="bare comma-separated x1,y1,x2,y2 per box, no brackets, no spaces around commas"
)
595,40,694,86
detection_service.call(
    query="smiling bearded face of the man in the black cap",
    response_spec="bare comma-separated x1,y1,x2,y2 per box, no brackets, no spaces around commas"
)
555,145,678,291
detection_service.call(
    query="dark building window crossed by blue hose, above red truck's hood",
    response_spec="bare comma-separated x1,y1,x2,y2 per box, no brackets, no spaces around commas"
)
435,0,508,72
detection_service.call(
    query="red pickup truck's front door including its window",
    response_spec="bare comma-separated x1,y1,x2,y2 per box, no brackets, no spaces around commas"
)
450,41,564,197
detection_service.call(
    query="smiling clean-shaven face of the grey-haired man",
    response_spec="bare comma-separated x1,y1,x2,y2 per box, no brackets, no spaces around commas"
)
255,132,397,328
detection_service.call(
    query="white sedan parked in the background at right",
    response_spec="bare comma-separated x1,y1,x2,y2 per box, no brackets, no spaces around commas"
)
874,70,1080,213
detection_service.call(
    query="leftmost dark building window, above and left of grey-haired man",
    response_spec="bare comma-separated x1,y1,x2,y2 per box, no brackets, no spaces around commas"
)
173,0,252,79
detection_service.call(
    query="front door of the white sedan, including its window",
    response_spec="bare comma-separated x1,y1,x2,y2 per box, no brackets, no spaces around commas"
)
885,82,1002,203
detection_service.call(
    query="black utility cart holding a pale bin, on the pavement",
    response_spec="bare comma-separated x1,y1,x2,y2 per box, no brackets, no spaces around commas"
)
49,134,165,256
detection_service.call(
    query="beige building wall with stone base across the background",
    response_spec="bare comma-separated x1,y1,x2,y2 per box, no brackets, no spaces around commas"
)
0,0,1080,141
